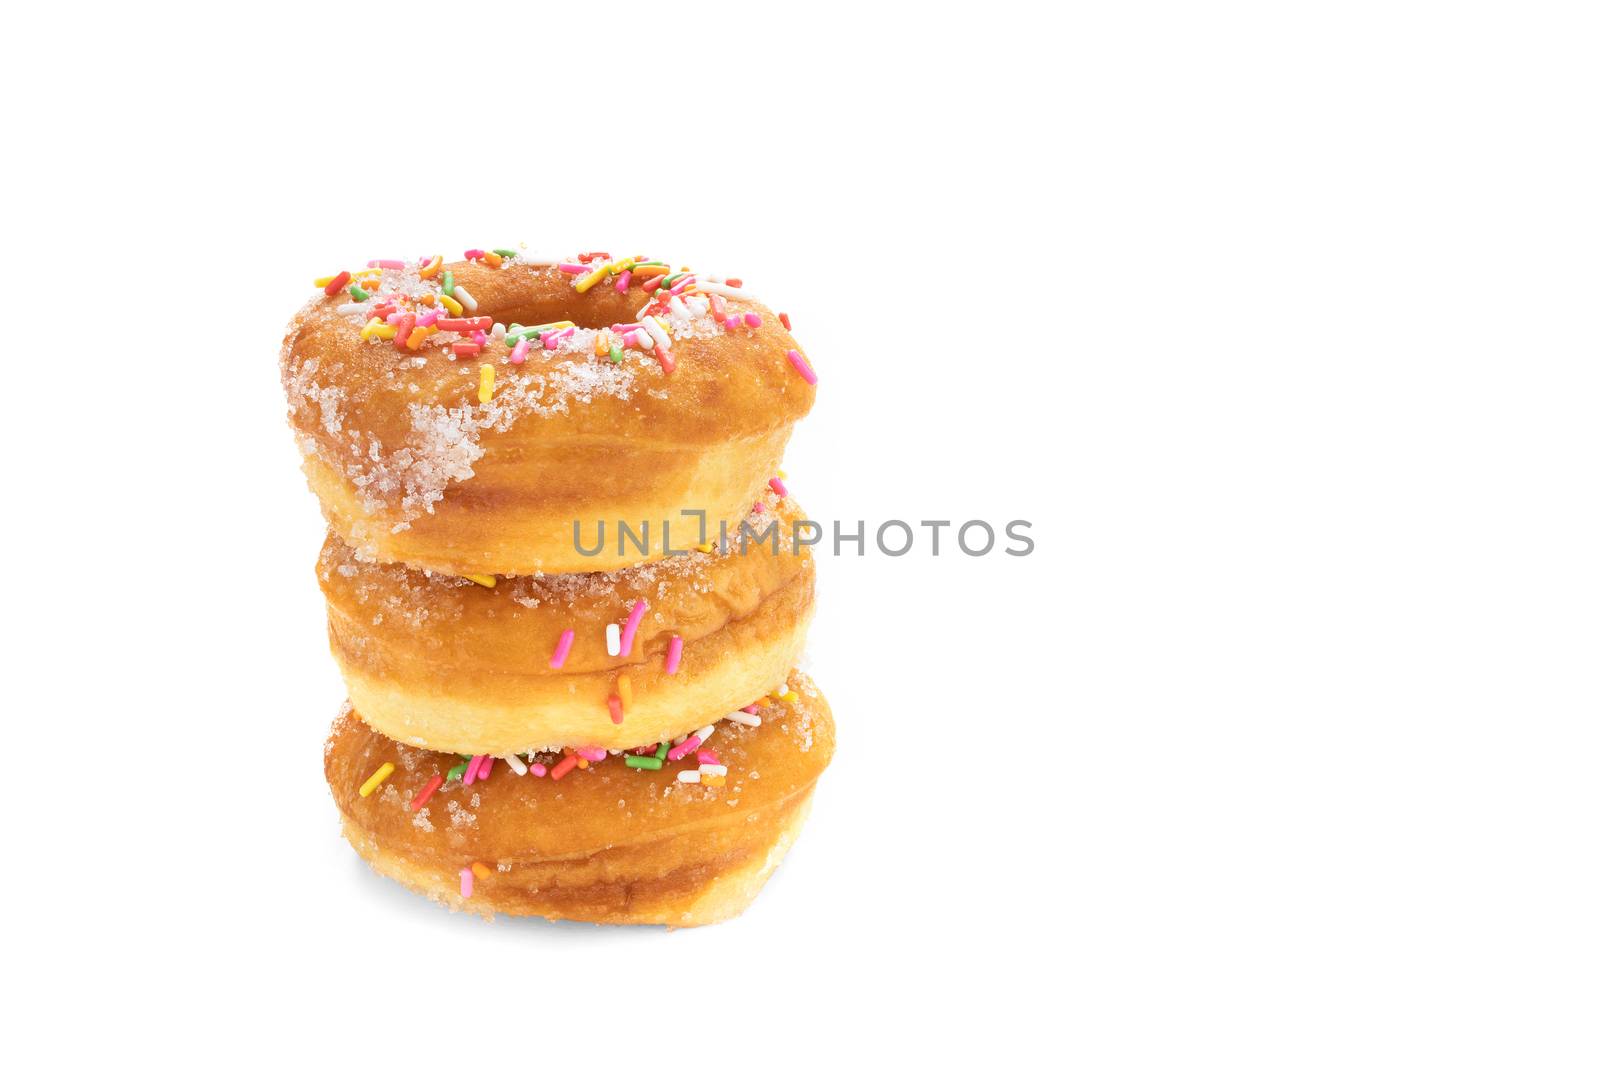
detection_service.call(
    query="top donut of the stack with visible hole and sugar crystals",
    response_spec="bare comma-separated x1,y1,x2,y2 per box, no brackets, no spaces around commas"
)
280,250,816,574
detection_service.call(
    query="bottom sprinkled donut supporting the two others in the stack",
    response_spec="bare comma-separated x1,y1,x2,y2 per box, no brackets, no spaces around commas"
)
323,672,834,926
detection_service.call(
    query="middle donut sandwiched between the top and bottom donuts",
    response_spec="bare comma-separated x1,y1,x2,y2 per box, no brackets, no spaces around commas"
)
317,494,816,755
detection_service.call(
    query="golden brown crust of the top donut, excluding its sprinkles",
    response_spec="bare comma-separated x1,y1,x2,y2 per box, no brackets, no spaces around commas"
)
282,259,814,574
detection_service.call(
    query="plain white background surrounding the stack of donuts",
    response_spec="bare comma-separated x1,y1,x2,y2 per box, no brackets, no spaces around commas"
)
0,3,1600,1064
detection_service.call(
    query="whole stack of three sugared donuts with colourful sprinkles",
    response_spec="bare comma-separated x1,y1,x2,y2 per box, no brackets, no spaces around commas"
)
282,250,834,926
